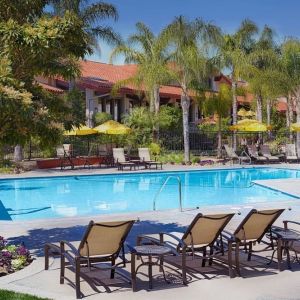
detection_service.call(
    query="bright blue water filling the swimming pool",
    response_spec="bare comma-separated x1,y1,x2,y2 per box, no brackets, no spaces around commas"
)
0,168,300,220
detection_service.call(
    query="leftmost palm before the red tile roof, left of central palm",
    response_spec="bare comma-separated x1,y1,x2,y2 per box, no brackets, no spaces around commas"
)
111,22,171,140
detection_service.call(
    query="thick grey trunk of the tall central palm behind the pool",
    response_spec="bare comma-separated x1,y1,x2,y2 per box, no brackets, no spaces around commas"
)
181,86,190,163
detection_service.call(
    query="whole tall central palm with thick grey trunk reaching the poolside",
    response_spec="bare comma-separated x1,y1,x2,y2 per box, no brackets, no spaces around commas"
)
166,16,221,162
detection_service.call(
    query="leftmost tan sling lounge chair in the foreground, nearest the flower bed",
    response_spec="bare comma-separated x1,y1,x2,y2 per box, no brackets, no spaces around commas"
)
56,220,135,299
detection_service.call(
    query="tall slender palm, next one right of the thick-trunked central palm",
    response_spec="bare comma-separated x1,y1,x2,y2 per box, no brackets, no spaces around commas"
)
222,19,258,149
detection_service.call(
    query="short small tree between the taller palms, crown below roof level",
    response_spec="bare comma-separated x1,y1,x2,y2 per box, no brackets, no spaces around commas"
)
204,84,232,158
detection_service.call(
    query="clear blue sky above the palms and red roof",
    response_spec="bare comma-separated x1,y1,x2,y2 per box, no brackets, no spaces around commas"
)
87,0,300,64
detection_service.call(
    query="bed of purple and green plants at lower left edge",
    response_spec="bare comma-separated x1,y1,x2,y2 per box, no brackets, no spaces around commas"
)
0,236,32,276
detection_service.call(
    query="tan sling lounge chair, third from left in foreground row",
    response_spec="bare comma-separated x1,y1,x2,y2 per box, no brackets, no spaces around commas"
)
222,209,284,277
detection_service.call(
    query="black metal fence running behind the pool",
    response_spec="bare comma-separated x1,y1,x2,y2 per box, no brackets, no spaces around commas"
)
2,129,295,159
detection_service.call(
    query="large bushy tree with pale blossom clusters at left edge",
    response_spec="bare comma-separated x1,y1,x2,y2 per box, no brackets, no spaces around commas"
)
0,1,91,158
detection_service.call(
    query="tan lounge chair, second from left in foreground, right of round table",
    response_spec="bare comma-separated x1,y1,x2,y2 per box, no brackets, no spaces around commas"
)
137,213,234,285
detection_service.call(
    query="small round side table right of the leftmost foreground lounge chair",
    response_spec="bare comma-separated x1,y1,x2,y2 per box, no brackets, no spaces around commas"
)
131,245,171,292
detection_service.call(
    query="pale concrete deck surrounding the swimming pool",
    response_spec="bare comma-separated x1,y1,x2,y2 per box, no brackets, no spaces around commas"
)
0,164,300,300
